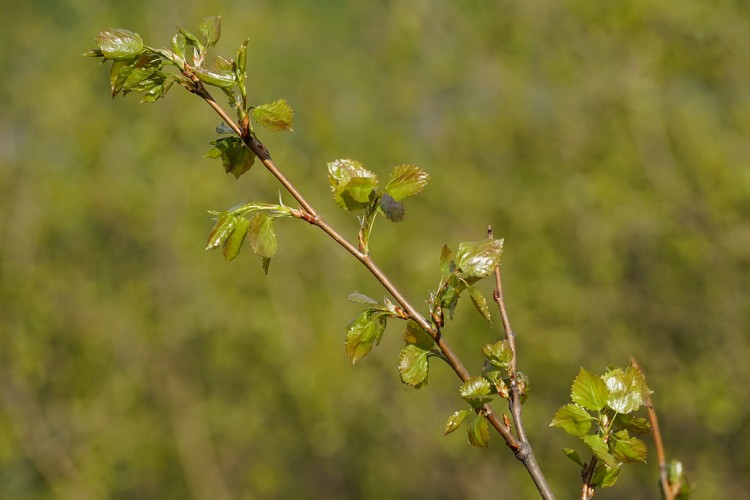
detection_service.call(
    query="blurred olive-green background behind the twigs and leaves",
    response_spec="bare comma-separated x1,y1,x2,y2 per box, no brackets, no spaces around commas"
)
0,0,750,499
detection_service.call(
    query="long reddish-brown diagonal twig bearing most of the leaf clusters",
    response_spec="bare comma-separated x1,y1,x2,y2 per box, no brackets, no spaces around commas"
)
195,81,555,500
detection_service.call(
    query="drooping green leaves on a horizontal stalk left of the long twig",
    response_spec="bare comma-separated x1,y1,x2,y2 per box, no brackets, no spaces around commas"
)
206,203,292,274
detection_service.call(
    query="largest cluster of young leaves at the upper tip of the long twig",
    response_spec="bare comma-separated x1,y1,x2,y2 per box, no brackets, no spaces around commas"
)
84,16,294,178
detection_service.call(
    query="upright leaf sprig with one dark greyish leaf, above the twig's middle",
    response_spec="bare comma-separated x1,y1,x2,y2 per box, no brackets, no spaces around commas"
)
328,159,430,253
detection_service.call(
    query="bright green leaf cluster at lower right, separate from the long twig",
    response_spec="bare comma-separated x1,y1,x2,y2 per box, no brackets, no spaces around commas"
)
550,366,651,488
